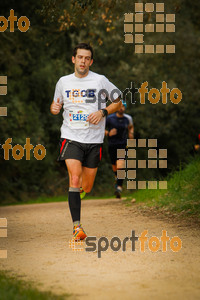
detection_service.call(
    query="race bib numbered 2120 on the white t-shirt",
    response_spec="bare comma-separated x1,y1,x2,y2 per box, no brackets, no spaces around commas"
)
69,109,89,129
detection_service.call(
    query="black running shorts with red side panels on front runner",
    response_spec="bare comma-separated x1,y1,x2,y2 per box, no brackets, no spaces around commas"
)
58,138,102,168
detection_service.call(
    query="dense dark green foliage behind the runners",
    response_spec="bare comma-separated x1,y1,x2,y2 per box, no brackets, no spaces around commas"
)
0,0,200,201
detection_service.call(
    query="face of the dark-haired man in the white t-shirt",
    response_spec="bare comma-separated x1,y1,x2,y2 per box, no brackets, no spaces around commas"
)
72,49,93,77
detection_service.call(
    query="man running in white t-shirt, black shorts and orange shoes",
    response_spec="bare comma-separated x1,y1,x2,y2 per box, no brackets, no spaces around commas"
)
50,43,122,240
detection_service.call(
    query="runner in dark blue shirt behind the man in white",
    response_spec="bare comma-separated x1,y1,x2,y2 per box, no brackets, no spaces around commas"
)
105,102,134,198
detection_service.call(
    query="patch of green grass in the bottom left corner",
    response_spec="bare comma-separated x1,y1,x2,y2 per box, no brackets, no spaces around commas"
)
0,271,69,300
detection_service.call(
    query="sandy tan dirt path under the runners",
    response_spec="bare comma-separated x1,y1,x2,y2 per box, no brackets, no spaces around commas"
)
0,199,200,300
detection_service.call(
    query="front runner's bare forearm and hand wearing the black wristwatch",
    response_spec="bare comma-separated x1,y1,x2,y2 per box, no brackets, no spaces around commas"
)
88,98,122,124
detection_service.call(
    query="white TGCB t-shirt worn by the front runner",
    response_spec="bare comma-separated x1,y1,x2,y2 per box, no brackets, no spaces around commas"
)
54,71,121,144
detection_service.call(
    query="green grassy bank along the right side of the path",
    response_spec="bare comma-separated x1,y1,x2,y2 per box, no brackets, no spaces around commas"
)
128,157,200,218
